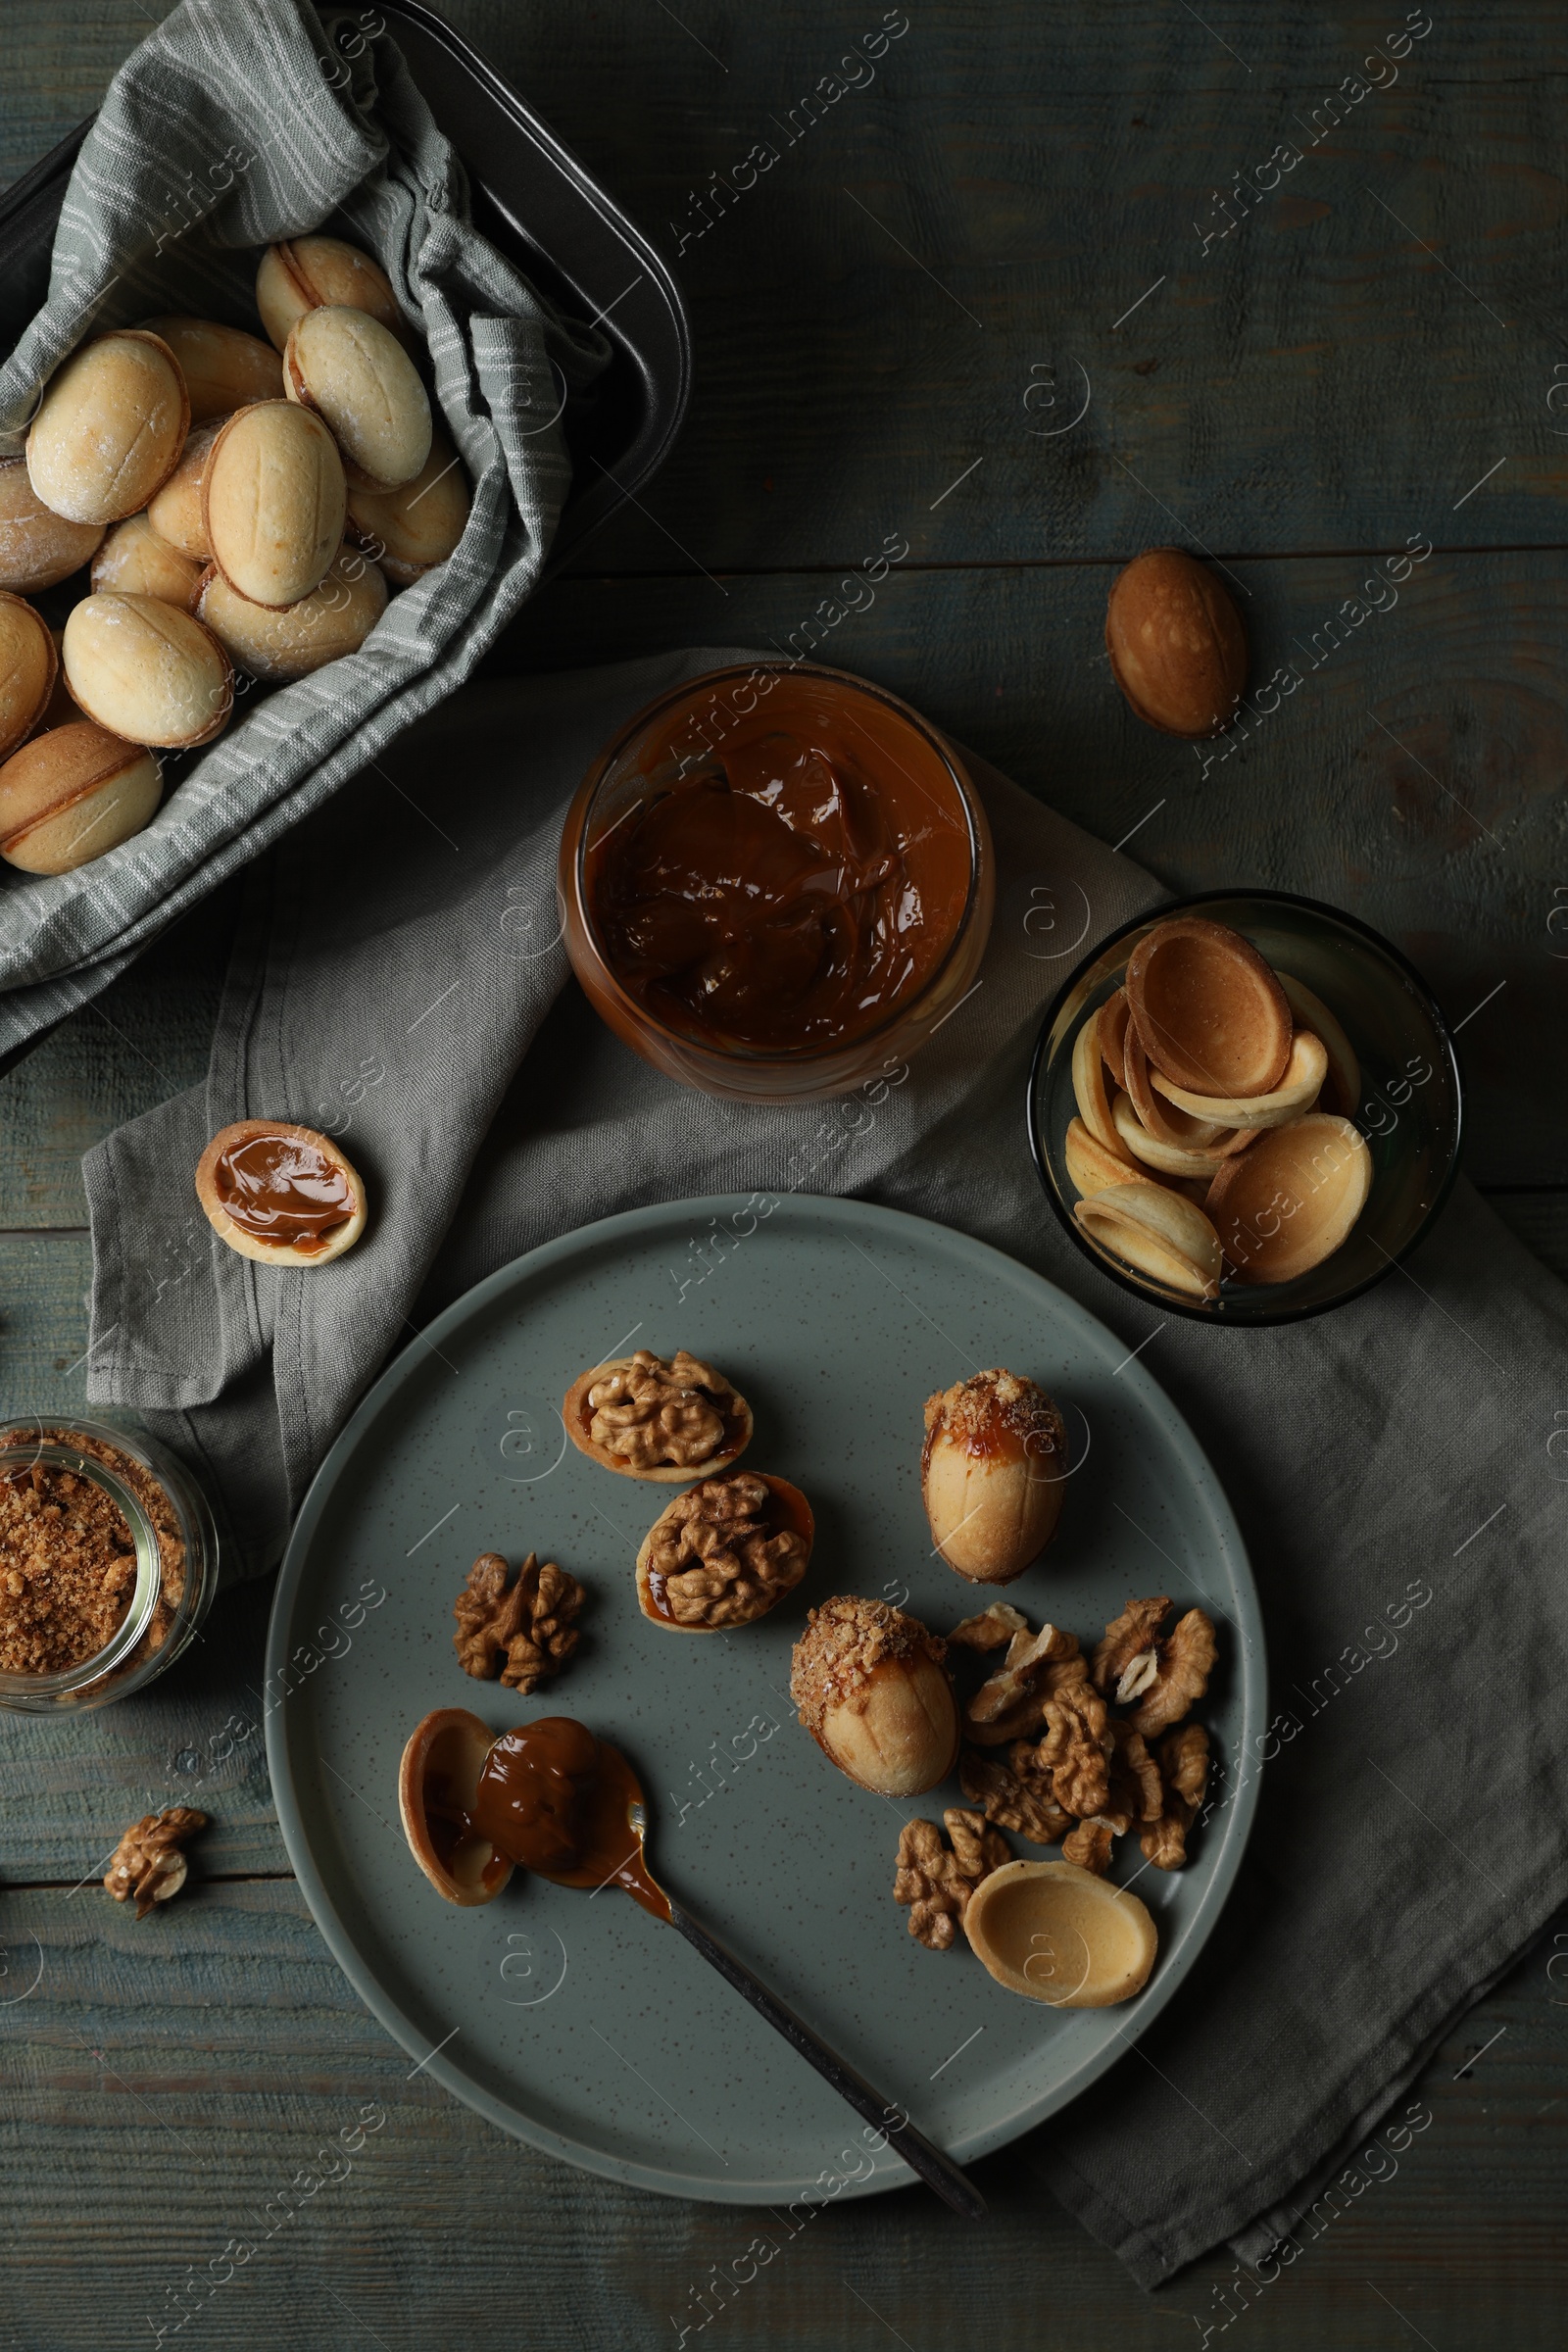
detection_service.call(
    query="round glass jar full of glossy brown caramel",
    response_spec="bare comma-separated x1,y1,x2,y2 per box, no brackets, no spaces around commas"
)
560,661,995,1103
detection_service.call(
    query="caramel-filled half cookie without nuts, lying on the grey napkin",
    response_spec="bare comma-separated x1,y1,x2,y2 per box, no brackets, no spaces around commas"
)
195,1119,367,1265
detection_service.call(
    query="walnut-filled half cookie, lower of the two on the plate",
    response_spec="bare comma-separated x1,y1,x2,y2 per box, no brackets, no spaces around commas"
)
637,1470,815,1633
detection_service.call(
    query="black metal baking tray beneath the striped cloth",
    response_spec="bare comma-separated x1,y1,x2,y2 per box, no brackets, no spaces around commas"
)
0,0,691,578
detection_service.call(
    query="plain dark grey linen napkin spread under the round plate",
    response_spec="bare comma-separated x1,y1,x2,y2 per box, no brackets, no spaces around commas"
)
87,652,1568,2283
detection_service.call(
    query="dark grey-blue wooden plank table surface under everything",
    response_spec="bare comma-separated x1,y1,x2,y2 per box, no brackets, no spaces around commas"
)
0,0,1568,2352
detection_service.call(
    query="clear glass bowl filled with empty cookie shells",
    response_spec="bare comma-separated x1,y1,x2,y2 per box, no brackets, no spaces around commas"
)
1027,892,1462,1324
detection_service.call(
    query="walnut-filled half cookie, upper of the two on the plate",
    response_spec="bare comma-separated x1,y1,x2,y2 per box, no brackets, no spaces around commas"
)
562,1348,753,1487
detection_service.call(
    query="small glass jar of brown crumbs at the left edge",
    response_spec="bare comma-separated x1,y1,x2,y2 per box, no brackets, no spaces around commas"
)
0,1416,219,1715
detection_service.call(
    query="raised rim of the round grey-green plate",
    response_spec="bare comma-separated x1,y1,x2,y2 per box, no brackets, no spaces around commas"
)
266,1193,1267,2204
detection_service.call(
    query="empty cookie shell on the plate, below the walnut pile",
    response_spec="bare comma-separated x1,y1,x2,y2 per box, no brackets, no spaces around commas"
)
964,1863,1159,2009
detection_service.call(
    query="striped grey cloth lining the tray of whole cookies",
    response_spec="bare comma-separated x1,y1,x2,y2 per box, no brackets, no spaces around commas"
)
0,0,607,1058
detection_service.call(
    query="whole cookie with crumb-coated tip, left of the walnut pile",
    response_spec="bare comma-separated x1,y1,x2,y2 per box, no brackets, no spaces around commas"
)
790,1594,959,1797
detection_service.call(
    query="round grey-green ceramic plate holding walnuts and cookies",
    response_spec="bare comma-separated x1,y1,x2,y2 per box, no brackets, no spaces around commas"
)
268,1195,1265,2204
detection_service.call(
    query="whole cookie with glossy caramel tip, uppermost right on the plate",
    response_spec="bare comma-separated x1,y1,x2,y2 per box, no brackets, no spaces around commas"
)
919,1369,1067,1586
